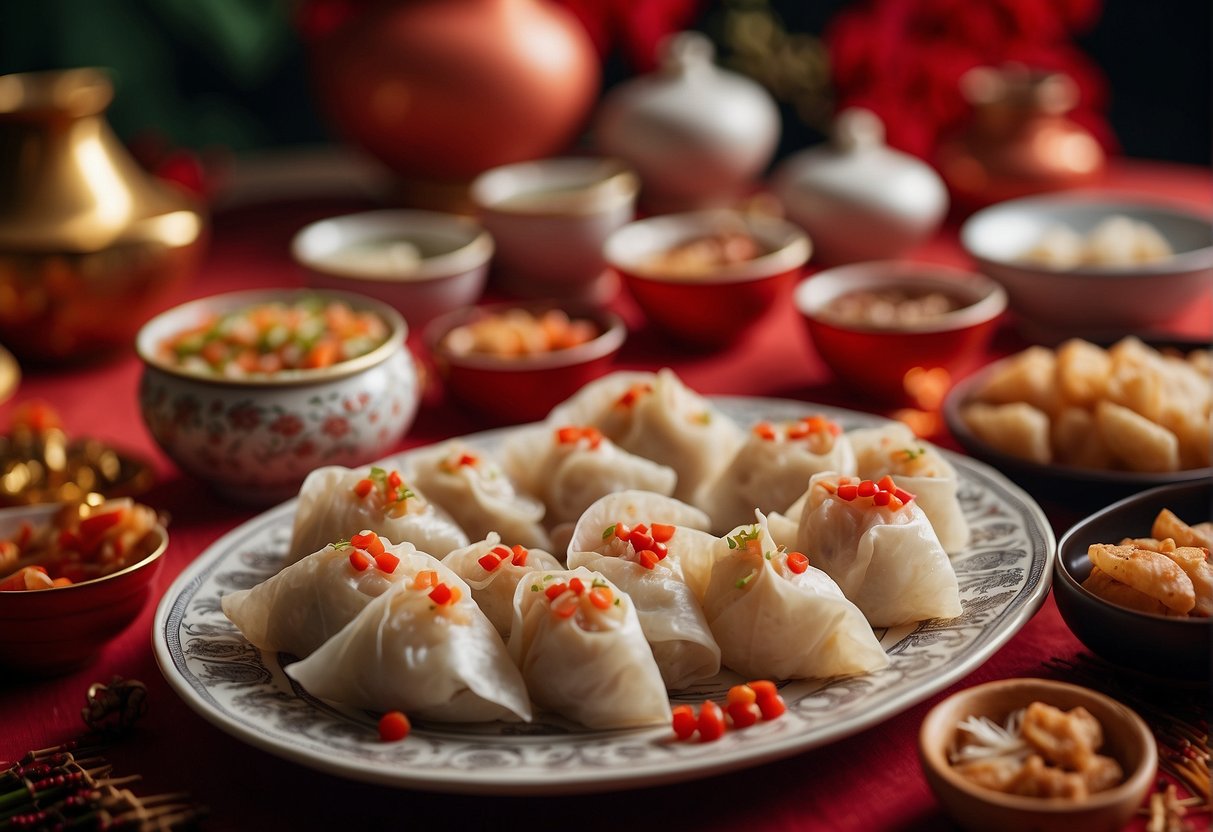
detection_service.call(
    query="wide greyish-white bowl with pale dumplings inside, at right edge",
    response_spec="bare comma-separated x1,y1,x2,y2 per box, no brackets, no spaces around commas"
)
961,192,1213,342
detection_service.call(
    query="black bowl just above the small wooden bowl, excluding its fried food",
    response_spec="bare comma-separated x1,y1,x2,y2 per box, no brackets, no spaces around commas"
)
1053,479,1213,680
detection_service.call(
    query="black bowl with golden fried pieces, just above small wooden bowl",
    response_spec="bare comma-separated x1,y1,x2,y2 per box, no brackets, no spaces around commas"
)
1053,480,1213,680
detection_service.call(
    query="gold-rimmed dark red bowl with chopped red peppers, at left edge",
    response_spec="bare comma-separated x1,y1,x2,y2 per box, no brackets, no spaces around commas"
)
0,497,169,676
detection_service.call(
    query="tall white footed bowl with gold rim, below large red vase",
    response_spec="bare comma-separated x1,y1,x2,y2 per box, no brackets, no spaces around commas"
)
471,158,639,301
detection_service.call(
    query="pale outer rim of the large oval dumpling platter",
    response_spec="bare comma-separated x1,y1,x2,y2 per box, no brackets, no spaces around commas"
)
152,395,1057,796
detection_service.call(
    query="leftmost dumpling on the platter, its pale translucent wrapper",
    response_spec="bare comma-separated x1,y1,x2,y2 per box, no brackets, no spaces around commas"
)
221,543,417,657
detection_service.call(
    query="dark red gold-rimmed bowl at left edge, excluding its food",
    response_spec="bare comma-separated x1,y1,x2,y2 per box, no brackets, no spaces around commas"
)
0,505,169,676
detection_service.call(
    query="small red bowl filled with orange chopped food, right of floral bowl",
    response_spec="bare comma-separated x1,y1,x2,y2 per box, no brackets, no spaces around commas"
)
426,302,627,423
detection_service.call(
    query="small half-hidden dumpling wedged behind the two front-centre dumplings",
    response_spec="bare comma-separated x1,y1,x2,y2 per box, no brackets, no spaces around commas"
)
443,532,564,639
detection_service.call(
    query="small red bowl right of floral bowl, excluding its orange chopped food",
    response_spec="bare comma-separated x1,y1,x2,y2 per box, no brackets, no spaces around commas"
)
425,303,627,423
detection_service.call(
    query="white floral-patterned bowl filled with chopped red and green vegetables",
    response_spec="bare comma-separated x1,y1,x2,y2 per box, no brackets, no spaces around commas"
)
136,290,418,503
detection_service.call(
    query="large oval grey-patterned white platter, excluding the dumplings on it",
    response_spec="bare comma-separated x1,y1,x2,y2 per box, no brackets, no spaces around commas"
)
153,397,1054,794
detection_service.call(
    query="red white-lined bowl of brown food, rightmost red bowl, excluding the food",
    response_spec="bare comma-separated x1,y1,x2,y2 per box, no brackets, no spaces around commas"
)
793,261,1007,404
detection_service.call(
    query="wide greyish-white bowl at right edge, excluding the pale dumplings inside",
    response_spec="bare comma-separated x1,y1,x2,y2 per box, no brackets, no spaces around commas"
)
961,192,1213,342
